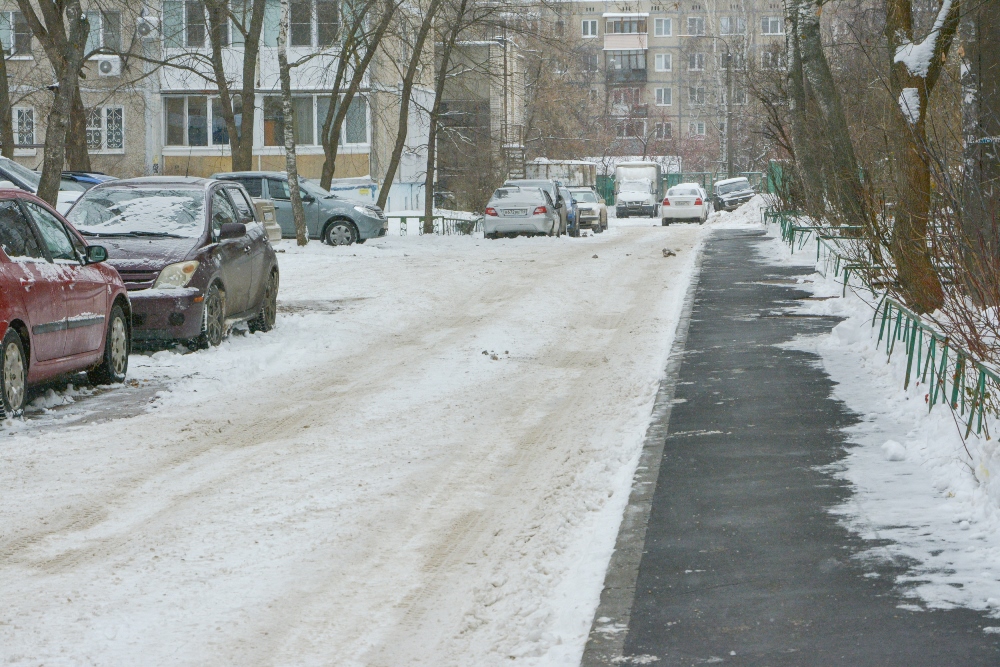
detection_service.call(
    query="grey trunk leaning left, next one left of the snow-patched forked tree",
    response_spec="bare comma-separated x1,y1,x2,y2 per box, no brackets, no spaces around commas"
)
794,0,868,225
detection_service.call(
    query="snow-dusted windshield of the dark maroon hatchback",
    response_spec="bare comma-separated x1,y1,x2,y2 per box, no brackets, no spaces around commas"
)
68,188,205,238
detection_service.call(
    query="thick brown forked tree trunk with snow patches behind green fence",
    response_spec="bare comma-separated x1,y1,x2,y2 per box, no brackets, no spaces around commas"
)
885,0,959,313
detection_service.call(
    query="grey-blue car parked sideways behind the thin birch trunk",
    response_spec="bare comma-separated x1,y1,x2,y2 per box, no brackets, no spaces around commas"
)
212,171,389,245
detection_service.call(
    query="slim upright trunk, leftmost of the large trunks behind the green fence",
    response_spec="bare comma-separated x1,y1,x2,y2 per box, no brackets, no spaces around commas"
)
785,0,826,220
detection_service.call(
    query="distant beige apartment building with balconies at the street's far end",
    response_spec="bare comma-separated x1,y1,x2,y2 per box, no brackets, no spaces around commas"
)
548,0,784,171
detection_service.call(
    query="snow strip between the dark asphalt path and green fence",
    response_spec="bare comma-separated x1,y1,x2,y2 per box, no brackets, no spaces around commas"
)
744,202,1000,632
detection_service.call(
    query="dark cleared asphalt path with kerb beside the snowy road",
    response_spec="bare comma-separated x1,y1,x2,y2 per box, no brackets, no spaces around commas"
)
583,230,1000,667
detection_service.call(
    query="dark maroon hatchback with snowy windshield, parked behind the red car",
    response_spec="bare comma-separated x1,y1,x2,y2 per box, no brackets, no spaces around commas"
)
68,176,278,347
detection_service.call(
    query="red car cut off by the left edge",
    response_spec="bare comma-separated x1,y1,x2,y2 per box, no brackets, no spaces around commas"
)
0,190,131,417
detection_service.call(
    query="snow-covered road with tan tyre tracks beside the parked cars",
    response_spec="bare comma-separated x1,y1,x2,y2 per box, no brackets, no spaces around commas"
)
0,221,708,667
